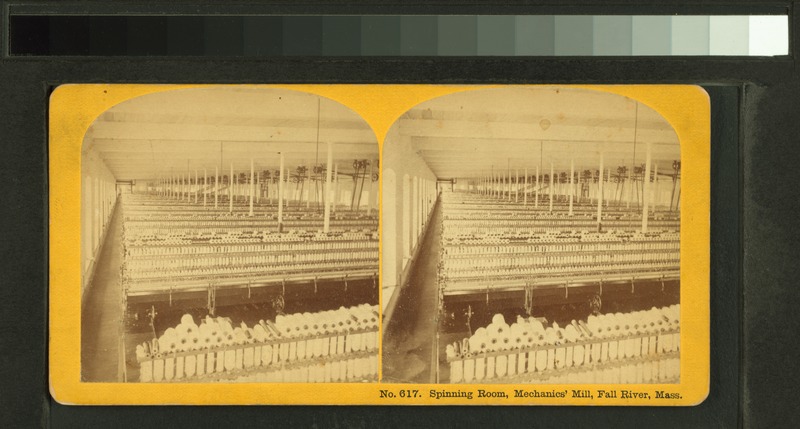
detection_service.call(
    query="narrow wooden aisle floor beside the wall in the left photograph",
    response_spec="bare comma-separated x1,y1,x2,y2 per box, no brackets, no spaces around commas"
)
81,200,123,382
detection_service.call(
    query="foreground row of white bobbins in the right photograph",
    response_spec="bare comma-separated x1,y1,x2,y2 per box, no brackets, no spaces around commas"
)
445,304,680,383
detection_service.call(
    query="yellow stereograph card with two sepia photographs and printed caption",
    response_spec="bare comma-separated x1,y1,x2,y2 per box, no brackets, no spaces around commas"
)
49,84,711,406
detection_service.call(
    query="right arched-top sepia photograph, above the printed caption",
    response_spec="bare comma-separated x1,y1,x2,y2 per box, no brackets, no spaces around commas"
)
381,86,688,384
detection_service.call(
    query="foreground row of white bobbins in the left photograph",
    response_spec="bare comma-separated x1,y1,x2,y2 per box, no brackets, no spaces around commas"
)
136,304,379,382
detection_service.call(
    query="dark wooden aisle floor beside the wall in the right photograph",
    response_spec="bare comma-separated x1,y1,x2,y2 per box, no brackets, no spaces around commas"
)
383,201,442,383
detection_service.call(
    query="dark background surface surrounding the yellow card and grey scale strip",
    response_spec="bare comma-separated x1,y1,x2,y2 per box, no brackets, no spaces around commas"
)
0,0,800,428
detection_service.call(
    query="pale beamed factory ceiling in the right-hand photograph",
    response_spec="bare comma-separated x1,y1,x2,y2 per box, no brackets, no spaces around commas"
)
394,87,680,179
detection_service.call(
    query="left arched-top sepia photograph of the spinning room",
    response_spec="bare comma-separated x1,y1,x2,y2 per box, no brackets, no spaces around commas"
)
76,86,380,383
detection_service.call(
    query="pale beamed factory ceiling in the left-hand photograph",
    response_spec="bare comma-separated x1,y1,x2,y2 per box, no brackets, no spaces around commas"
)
83,86,378,180
